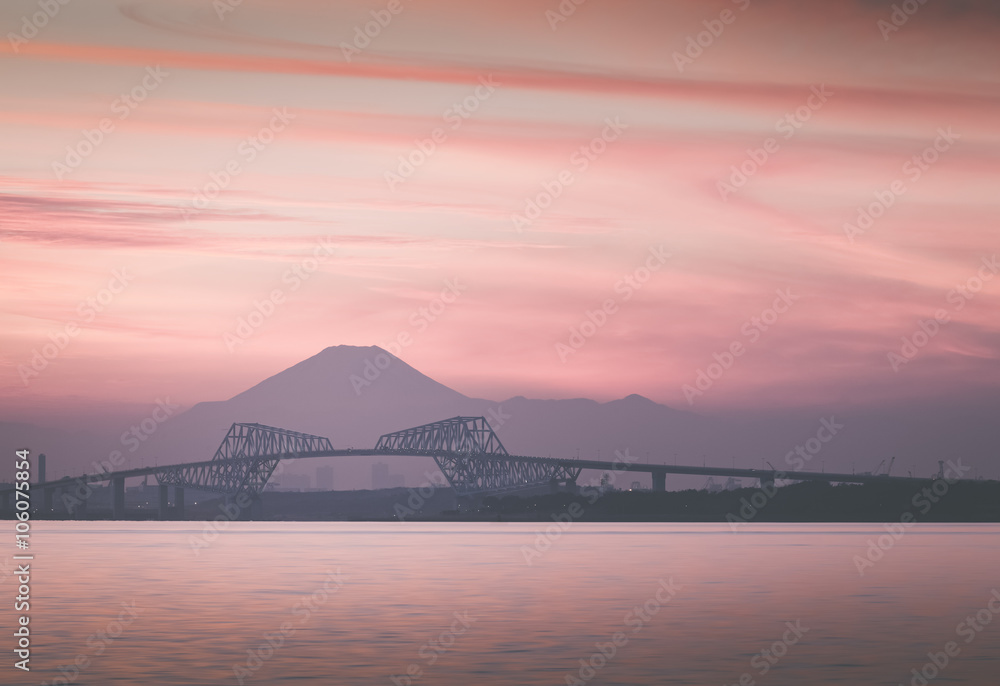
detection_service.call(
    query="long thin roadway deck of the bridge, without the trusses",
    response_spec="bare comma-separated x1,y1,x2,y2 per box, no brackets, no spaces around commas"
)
0,448,927,509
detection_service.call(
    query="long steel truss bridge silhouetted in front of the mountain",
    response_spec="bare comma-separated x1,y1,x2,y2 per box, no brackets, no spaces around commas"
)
0,417,948,519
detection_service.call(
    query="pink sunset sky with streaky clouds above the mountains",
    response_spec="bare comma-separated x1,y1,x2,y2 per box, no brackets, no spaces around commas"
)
0,0,1000,421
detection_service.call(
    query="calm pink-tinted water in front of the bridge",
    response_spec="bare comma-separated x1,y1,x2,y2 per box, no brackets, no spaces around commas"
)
0,522,1000,686
